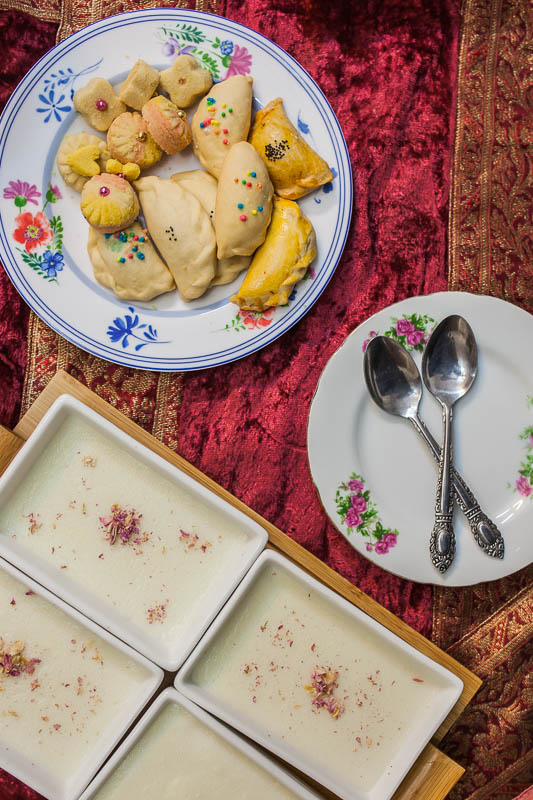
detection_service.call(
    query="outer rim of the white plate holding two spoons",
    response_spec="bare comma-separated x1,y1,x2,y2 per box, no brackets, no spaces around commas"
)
306,290,533,589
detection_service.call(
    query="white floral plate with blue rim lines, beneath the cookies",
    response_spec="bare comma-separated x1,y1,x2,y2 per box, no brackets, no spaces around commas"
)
0,9,352,371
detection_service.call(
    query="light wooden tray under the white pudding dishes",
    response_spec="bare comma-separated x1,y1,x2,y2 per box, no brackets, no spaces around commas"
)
0,371,474,800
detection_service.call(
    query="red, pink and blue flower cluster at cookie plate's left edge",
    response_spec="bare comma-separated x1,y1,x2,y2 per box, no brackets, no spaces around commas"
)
3,180,64,283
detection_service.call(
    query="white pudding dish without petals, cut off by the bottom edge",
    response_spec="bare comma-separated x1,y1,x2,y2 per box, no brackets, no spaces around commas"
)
80,688,318,800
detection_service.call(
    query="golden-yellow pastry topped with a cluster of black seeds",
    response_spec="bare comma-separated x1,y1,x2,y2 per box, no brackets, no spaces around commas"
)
250,97,333,200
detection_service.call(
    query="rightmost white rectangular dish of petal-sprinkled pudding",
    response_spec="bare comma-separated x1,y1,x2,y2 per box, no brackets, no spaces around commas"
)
176,551,463,800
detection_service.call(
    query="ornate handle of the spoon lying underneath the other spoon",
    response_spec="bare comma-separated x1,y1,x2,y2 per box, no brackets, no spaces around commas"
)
410,416,505,558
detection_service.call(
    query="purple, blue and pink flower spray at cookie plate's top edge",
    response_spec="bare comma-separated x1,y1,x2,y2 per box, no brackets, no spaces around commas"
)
157,23,252,81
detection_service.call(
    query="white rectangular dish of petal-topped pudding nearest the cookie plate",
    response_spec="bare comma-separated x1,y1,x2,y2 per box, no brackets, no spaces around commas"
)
0,395,267,670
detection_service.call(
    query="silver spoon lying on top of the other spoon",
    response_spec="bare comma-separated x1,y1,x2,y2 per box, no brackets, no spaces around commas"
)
422,314,477,572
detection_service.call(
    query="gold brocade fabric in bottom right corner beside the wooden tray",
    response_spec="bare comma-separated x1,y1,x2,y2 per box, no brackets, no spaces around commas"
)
443,584,533,800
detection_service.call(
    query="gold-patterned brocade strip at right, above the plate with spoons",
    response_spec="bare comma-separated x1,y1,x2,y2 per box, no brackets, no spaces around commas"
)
448,0,533,311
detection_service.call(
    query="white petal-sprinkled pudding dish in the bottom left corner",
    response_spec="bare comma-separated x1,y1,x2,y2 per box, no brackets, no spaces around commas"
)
0,559,163,800
